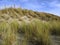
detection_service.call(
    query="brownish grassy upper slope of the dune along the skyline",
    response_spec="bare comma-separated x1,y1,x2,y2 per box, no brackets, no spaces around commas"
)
0,8,60,21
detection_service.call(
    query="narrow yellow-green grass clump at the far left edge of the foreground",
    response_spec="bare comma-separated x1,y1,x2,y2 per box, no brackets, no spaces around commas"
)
0,21,8,45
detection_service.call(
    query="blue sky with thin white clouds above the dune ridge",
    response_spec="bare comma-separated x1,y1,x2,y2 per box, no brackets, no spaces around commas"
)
0,0,60,16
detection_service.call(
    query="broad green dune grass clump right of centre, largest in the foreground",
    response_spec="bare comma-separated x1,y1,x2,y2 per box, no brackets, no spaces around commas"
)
18,19,50,45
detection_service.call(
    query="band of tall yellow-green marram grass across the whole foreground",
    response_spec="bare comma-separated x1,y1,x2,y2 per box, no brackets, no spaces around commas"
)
0,19,60,45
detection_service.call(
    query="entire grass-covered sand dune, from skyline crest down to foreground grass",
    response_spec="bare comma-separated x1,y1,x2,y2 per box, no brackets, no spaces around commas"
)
0,8,60,45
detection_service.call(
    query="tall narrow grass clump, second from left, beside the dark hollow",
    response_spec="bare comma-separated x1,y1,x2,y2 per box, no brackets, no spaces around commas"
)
9,20,19,45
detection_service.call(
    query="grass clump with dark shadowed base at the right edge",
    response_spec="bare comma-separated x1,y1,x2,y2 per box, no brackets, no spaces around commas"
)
49,21,60,35
